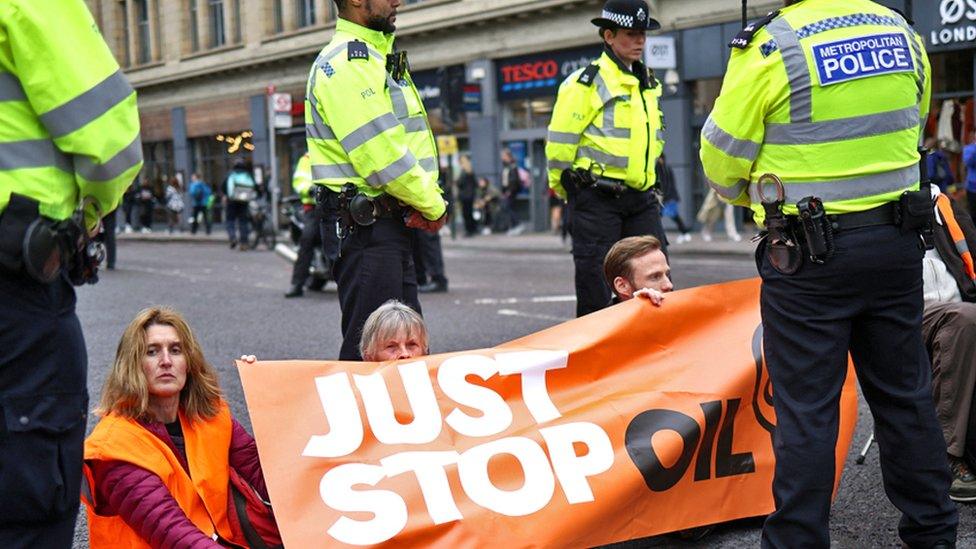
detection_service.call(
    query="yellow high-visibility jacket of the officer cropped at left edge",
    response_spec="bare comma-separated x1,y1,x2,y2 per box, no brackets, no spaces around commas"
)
0,0,142,225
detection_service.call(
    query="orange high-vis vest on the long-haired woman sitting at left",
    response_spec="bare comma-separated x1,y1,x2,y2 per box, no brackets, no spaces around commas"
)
82,401,247,549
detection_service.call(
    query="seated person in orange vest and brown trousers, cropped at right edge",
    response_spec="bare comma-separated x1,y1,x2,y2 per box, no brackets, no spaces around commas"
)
922,194,976,502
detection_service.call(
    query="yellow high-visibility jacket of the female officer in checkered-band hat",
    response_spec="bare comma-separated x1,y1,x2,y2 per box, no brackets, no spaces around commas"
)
546,52,664,198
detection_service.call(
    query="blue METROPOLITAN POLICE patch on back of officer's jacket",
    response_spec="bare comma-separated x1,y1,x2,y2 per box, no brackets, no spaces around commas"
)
813,33,915,86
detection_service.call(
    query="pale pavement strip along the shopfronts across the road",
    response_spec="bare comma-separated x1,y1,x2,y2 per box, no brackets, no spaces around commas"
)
117,226,756,256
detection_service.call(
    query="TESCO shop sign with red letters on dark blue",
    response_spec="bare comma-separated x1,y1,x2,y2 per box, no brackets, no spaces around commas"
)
495,46,603,101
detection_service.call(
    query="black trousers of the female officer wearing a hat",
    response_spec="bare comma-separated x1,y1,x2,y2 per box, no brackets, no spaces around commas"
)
569,187,667,317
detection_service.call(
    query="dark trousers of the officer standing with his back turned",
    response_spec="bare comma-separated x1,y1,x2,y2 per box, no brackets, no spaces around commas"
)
756,225,958,548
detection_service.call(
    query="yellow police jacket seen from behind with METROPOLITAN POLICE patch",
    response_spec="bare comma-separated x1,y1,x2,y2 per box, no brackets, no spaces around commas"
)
701,0,931,225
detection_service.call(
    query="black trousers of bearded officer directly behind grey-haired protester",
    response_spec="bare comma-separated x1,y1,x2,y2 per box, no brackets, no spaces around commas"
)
332,214,420,360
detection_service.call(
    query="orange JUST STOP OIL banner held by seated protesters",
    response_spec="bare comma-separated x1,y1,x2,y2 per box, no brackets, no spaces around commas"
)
238,279,857,547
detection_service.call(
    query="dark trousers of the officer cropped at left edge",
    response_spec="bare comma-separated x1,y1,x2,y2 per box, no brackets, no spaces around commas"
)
0,271,88,549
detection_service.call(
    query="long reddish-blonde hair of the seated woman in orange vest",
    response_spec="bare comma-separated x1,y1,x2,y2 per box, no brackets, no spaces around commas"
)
95,307,221,421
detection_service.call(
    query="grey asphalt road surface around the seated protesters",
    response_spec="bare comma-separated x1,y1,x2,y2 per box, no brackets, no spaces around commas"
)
75,241,976,548
